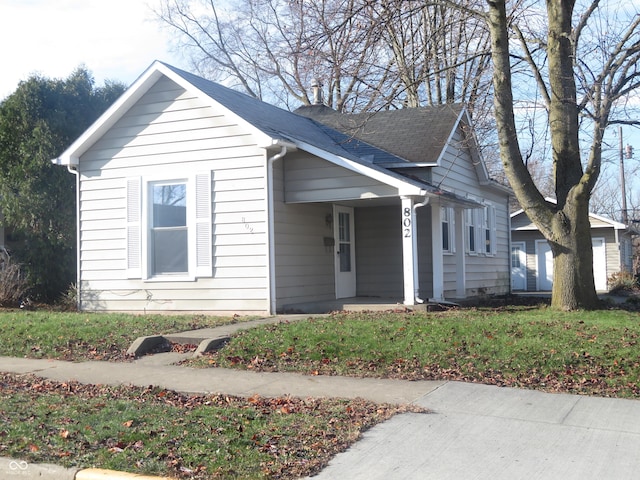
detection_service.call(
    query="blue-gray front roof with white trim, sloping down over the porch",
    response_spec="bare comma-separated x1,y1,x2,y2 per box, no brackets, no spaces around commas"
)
52,61,474,205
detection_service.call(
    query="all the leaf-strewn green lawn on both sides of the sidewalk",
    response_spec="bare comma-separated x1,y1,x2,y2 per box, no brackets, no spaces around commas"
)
0,307,640,479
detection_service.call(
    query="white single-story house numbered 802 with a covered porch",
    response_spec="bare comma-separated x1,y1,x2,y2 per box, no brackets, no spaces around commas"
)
52,62,510,313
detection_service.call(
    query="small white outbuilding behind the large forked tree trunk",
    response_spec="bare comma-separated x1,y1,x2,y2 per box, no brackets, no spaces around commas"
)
511,210,633,292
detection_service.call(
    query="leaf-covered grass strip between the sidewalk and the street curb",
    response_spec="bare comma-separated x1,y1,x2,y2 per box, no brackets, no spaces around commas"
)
0,374,424,479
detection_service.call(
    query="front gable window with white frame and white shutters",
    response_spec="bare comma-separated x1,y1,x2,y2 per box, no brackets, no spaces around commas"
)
126,172,212,281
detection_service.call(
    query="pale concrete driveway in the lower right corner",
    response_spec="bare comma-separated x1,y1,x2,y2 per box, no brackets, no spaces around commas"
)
313,382,640,480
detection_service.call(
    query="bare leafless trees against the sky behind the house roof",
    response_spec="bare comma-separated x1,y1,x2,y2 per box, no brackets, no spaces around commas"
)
156,0,491,113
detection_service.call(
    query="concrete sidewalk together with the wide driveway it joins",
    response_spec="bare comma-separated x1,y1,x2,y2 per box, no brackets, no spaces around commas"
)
0,316,640,480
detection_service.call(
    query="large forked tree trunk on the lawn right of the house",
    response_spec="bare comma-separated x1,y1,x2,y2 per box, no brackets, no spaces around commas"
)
487,0,599,310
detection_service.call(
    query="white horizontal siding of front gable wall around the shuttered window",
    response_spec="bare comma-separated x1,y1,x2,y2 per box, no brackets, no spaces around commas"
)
79,78,269,312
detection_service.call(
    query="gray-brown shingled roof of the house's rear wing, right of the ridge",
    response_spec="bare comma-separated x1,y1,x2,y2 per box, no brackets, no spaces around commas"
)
294,104,464,166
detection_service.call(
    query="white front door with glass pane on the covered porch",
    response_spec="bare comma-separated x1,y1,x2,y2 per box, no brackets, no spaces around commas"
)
333,205,356,298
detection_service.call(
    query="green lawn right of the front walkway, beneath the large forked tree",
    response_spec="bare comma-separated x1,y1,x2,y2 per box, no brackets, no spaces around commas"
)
190,307,640,398
